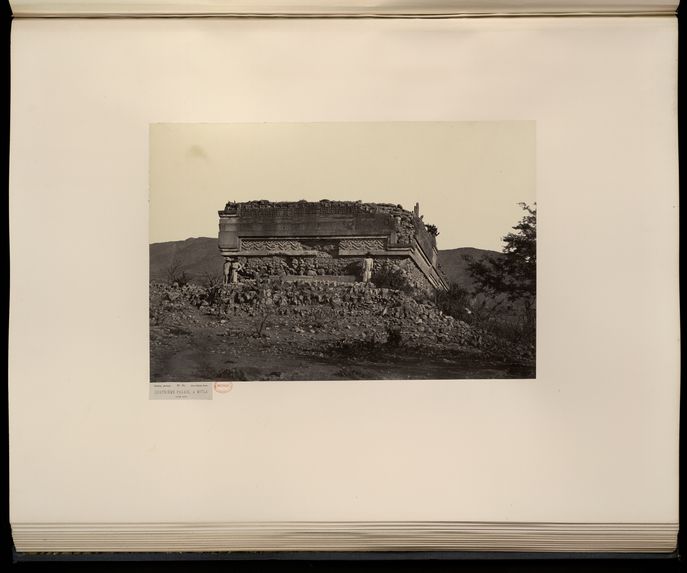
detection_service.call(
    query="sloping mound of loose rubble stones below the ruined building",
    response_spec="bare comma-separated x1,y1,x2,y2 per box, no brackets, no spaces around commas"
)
150,280,531,358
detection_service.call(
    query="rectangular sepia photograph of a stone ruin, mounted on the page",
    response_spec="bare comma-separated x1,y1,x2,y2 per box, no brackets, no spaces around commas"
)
149,121,537,382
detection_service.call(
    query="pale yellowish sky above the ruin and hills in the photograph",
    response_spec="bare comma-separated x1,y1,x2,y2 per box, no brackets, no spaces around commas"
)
150,121,536,250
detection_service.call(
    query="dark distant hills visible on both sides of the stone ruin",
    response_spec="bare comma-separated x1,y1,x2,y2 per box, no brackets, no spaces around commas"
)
150,237,500,288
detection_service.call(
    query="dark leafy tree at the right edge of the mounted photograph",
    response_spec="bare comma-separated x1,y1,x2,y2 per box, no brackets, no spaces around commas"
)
466,203,537,315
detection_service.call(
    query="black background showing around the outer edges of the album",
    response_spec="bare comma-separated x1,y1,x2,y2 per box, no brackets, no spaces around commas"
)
0,0,686,573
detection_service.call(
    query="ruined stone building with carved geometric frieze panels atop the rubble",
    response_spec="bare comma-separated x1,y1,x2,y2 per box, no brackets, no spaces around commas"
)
219,200,447,291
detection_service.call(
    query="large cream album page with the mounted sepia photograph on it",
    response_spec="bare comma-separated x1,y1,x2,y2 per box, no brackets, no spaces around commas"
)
9,13,679,548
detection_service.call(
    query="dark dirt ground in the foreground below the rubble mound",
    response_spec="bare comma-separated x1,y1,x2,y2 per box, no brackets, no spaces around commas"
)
150,305,534,382
